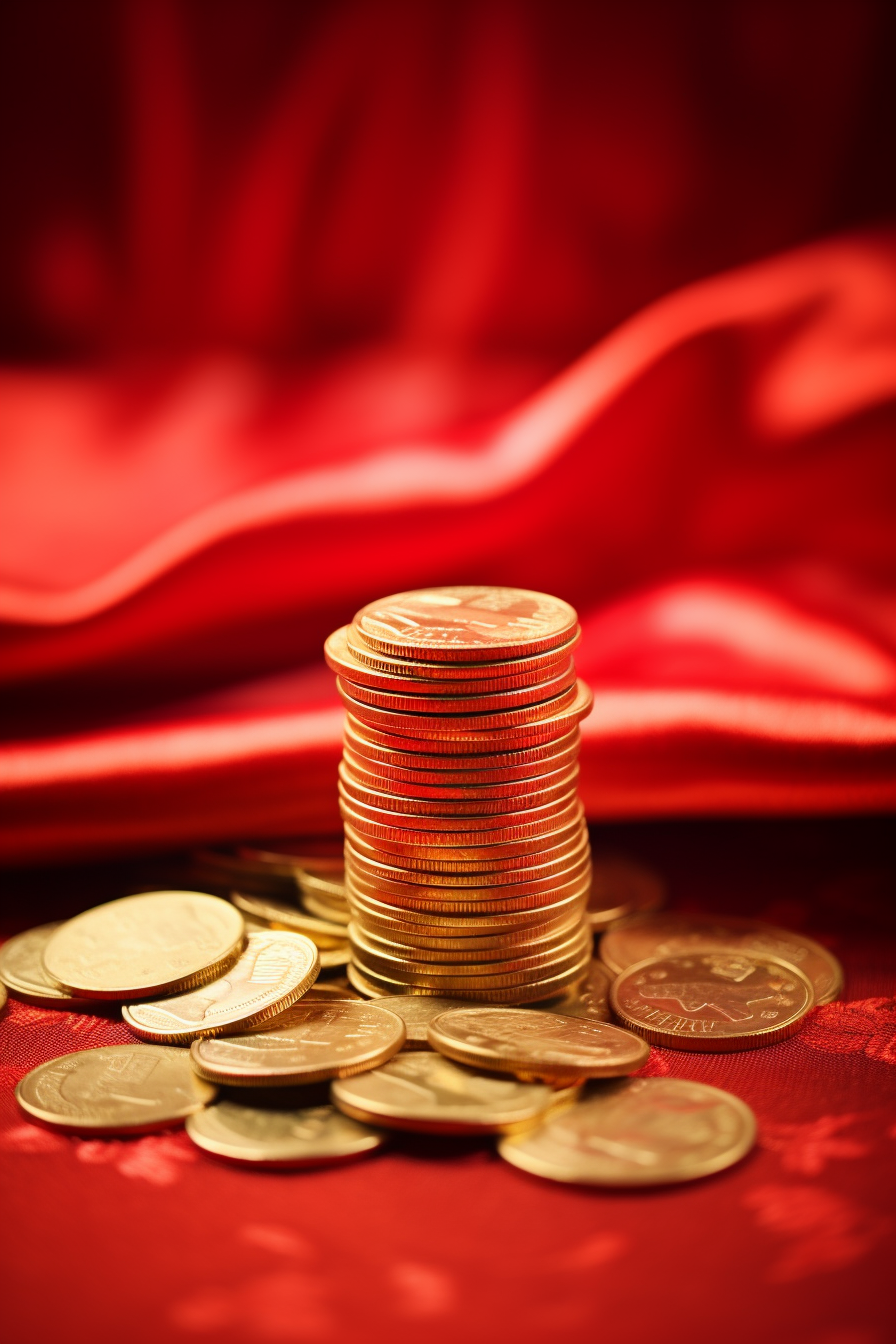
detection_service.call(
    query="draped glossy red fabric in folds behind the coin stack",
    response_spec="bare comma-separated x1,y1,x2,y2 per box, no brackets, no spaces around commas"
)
0,0,896,862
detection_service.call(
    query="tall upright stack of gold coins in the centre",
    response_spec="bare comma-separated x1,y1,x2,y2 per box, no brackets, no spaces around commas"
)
325,587,591,1003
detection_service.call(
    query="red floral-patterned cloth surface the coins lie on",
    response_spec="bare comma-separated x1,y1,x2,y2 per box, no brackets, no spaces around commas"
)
0,818,896,1344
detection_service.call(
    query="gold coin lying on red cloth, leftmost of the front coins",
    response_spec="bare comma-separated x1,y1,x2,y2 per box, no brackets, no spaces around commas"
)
16,1042,218,1136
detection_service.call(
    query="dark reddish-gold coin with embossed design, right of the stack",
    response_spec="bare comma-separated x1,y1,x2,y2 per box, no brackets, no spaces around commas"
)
610,948,814,1051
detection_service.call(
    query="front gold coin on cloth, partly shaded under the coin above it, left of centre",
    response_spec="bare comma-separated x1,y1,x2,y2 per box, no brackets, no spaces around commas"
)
187,1101,386,1168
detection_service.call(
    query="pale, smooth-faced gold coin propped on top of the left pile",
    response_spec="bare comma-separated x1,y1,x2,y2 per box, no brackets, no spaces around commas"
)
43,891,244,1000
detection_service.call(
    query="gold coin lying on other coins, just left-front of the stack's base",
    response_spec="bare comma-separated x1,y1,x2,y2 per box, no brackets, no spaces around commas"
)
191,1001,404,1087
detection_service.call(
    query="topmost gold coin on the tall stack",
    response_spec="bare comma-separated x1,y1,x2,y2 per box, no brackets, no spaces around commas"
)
352,586,578,663
